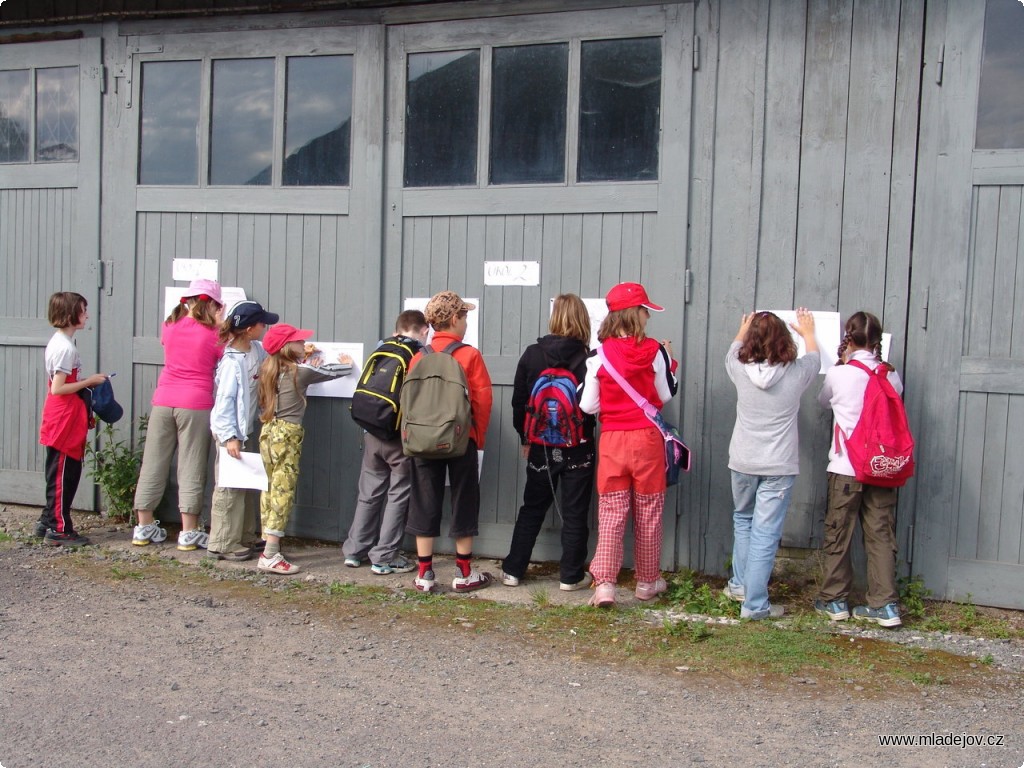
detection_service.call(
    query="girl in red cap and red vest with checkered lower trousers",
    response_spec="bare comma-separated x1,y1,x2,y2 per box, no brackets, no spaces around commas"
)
580,283,679,607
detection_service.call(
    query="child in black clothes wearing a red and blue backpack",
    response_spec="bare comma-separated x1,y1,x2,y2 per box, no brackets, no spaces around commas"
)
502,294,597,592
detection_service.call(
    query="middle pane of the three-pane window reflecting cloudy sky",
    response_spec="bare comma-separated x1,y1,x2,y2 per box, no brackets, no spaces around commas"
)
210,58,273,185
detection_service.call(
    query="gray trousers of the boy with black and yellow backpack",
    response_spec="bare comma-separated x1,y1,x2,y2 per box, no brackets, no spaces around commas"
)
341,432,413,563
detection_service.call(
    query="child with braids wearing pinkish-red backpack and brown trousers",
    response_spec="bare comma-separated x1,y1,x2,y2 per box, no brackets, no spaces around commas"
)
814,311,913,628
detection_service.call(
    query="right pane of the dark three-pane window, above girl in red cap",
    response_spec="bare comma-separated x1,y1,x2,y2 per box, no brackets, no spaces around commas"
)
579,38,662,181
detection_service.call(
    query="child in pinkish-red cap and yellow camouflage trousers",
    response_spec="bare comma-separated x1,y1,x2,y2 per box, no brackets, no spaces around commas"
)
256,323,352,574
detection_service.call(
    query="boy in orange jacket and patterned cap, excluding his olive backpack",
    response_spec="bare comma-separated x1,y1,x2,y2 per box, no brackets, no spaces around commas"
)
406,291,493,592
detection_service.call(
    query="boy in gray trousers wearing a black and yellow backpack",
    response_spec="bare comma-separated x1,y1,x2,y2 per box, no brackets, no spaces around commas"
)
341,309,429,575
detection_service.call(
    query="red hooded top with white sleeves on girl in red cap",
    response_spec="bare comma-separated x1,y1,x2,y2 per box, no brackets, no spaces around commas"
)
580,337,679,431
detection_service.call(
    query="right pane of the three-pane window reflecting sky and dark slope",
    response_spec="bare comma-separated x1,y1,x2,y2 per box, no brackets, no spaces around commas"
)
284,56,352,186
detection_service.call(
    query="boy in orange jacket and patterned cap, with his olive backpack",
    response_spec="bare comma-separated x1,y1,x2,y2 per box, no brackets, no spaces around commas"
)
401,291,493,592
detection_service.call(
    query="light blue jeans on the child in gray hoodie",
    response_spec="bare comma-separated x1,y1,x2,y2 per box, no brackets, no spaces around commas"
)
729,471,797,618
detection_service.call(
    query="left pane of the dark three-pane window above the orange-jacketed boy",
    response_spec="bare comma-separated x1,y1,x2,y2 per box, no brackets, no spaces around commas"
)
406,50,480,186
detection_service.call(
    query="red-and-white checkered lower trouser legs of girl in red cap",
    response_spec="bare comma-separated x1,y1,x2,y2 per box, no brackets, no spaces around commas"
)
590,490,665,584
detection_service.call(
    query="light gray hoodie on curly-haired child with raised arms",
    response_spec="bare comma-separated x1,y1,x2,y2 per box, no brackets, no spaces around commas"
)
725,341,821,476
